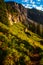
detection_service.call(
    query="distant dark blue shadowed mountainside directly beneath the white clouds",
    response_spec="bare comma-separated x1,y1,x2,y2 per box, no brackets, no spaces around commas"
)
27,8,43,24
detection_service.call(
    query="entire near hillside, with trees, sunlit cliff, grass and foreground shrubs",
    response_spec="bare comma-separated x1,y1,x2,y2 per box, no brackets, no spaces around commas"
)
0,0,43,65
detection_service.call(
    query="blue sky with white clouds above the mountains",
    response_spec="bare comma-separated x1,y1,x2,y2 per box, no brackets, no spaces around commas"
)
5,0,43,11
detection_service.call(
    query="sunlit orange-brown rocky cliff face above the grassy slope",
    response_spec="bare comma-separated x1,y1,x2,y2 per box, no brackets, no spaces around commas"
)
6,2,27,25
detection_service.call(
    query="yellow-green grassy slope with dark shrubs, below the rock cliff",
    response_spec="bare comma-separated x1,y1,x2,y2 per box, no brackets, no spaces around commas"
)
0,22,43,65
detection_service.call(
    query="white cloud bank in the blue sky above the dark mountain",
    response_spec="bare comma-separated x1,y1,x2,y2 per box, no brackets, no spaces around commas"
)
23,0,43,11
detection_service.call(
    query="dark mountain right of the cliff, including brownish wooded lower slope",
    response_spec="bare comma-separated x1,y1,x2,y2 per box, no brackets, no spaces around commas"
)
27,8,43,34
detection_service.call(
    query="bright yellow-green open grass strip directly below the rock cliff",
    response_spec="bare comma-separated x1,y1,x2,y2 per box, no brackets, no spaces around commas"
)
10,22,43,48
